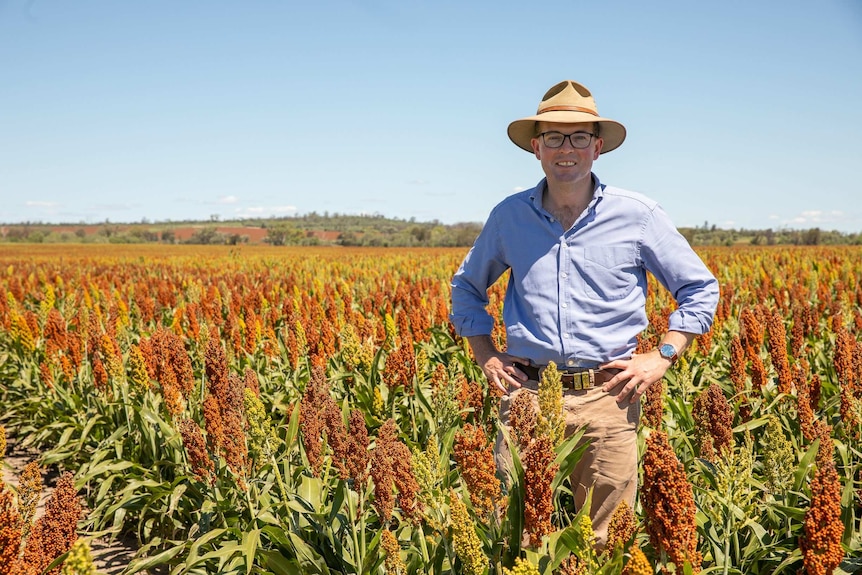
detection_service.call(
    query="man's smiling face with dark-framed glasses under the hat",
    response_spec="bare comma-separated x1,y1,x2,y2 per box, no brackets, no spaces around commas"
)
531,122,603,189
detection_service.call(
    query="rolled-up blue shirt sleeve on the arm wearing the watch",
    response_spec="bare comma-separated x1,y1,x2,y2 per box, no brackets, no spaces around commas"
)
641,206,719,334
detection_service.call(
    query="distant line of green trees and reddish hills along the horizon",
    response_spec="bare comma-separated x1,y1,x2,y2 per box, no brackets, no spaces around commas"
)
0,212,862,247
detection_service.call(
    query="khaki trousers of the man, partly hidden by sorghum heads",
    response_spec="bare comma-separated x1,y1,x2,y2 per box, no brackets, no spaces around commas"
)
495,381,640,550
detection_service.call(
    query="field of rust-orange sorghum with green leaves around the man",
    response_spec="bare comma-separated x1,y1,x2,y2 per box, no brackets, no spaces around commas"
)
0,245,862,575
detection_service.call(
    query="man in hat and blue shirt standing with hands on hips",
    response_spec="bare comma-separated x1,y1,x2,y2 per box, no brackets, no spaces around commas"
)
451,80,718,548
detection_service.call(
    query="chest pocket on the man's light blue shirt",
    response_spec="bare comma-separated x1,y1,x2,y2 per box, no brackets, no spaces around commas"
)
584,246,638,300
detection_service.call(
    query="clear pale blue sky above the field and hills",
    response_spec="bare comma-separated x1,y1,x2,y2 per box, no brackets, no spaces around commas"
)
0,0,862,232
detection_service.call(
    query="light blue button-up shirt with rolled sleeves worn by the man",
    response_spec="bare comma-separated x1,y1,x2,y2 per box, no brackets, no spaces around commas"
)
450,174,718,367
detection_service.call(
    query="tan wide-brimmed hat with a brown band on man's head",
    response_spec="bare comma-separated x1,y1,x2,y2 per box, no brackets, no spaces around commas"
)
509,80,626,154
